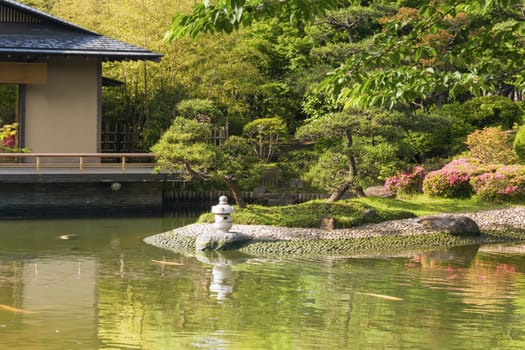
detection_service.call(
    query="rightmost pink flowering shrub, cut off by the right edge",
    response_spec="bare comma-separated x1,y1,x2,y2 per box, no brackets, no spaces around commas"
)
471,165,525,202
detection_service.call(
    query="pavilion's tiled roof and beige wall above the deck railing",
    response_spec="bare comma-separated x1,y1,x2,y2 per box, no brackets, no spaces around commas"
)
0,0,161,153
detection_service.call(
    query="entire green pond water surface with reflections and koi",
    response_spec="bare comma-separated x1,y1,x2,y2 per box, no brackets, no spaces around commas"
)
0,218,525,350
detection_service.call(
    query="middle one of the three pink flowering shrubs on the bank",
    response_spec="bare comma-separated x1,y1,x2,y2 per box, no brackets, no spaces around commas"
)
423,158,488,198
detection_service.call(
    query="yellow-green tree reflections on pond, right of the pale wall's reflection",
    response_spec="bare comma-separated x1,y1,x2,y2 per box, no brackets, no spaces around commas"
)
94,247,525,349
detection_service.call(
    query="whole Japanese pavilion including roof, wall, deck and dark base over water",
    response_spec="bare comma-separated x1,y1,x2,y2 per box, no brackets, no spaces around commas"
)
0,0,176,217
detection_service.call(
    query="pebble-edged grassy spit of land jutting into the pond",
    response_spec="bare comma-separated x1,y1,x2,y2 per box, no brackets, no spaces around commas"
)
138,195,525,256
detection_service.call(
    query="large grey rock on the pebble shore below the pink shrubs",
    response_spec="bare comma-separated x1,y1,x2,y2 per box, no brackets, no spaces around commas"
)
417,215,480,236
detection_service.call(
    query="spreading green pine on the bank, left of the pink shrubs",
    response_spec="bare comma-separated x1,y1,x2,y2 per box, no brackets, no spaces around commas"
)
296,110,420,196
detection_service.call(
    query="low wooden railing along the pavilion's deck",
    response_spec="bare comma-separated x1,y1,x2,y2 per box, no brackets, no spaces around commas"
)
0,152,155,172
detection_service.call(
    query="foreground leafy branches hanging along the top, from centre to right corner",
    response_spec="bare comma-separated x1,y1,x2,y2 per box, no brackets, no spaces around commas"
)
166,0,525,109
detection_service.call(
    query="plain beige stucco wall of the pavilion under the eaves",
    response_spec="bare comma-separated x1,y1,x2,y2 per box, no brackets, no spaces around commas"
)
23,58,101,153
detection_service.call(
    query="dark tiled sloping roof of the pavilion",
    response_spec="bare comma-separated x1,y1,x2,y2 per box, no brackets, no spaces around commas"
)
0,0,161,61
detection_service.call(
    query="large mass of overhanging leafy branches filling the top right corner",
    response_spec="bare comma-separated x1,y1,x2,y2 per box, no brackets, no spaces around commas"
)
320,0,525,109
